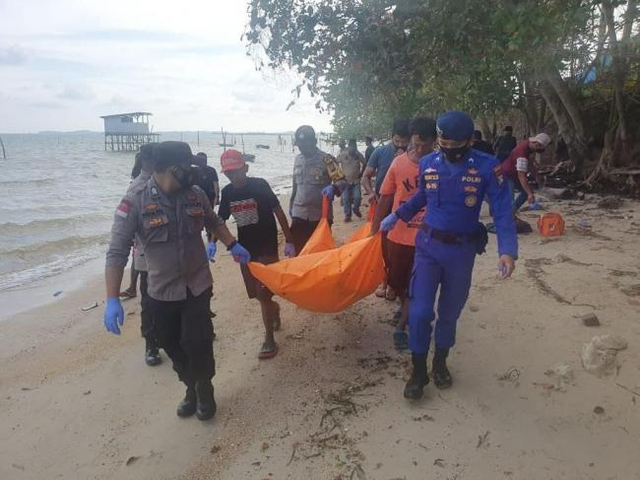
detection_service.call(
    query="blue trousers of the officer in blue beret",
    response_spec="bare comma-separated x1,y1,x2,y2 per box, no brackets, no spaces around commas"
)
409,230,476,355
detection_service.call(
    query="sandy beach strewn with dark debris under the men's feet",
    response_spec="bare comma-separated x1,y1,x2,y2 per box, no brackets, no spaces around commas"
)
0,192,640,480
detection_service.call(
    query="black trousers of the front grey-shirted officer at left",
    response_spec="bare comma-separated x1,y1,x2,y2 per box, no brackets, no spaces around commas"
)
149,288,216,386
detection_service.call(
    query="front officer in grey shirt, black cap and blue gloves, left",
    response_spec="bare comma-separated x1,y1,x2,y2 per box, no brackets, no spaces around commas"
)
104,142,250,420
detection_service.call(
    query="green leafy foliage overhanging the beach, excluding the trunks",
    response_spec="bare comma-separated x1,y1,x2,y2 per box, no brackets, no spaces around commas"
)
246,0,636,142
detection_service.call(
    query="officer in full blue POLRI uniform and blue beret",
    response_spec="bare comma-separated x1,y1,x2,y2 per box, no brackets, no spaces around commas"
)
380,111,518,400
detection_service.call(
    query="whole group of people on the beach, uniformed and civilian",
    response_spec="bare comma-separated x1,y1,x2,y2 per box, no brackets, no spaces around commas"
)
104,111,550,420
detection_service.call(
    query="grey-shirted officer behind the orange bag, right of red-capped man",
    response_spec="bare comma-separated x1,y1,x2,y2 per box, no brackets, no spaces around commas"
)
289,125,348,254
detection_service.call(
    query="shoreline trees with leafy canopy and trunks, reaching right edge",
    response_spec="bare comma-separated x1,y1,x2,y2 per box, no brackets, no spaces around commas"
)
246,0,640,180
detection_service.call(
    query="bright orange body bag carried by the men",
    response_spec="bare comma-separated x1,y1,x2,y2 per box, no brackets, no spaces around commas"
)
249,198,384,313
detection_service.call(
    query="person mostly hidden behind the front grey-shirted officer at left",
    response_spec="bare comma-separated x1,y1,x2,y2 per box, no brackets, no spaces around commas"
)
127,143,162,367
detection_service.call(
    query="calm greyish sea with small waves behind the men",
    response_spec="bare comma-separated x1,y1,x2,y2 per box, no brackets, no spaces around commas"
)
0,132,331,291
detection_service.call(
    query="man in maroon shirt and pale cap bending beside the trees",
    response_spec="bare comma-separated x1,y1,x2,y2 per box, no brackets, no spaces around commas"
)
502,133,551,214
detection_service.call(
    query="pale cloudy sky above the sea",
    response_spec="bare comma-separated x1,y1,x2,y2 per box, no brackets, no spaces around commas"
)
0,0,331,132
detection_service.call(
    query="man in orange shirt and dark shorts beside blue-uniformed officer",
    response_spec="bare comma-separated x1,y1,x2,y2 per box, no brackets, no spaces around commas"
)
371,117,436,350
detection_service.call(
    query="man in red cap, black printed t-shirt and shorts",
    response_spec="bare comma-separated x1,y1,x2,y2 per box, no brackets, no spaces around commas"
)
218,150,295,359
